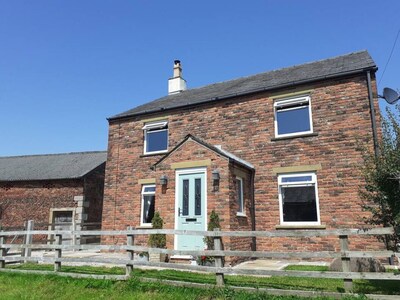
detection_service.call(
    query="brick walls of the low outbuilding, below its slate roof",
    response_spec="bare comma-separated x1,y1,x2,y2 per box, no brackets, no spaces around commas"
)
0,164,105,234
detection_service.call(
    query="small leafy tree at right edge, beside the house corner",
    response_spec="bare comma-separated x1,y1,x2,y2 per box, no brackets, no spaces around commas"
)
360,105,400,250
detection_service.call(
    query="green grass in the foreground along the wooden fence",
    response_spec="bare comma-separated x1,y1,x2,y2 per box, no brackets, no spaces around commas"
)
0,264,400,299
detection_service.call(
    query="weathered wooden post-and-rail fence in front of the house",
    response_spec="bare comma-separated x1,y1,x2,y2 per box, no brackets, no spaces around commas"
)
0,227,400,298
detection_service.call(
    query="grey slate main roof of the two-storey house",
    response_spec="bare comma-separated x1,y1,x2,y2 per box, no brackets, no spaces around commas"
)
109,50,376,120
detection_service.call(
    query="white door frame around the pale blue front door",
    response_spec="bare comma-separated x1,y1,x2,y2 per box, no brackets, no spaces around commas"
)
174,168,208,250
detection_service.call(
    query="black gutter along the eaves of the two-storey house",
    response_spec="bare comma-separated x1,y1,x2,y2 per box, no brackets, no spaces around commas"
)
107,66,378,122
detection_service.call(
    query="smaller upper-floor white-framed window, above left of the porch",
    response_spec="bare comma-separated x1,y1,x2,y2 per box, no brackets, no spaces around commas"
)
143,121,168,154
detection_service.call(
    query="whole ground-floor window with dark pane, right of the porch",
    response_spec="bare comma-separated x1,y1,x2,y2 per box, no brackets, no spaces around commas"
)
278,173,320,225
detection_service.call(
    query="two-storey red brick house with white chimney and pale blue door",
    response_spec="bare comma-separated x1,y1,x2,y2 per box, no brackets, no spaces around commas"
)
102,51,380,251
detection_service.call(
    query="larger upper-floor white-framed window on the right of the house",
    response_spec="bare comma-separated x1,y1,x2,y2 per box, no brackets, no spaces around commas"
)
274,96,313,137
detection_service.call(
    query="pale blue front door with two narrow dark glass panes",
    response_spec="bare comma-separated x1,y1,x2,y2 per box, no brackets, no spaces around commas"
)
176,171,207,250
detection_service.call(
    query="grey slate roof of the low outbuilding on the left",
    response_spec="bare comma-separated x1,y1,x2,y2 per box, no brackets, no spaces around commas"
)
0,151,107,181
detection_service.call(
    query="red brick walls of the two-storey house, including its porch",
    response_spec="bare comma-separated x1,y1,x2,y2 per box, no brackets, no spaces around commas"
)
103,75,381,251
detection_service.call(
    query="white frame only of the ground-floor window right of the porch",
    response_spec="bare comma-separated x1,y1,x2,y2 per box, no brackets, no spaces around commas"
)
278,172,321,226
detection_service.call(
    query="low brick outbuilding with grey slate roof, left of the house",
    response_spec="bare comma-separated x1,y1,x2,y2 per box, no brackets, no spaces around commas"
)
0,152,107,241
